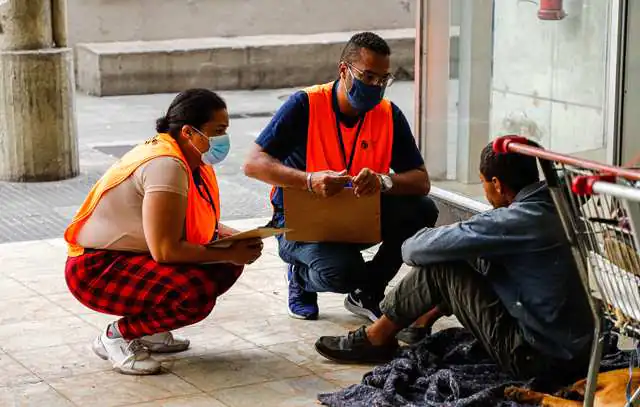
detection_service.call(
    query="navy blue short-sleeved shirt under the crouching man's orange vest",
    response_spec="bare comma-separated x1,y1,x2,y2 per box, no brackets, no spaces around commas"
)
256,81,424,226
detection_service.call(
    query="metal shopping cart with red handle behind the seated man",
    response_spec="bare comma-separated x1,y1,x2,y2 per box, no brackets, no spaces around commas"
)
493,136,640,407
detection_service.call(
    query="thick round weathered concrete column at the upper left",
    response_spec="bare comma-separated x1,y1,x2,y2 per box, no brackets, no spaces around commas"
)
0,0,79,182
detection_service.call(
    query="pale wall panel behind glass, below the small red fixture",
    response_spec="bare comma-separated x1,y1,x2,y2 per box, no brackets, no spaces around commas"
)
491,0,610,160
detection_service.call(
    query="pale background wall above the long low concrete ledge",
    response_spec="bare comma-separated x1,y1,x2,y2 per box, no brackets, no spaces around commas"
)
68,0,415,45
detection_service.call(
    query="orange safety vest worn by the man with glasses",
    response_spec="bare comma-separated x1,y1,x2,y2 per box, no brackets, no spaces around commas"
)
304,82,393,176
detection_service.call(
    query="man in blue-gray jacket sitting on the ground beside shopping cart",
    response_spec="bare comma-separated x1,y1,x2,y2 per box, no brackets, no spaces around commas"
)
316,142,593,382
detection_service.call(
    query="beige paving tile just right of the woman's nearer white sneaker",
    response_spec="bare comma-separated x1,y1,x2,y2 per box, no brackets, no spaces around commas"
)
170,348,310,392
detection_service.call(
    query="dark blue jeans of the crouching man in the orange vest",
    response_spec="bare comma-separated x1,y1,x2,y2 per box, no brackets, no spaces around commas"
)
278,195,438,298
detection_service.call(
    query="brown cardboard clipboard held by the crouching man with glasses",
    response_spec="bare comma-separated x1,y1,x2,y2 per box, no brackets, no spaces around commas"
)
283,188,382,244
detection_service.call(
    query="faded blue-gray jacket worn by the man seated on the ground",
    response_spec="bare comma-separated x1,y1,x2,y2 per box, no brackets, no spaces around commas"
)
402,182,593,359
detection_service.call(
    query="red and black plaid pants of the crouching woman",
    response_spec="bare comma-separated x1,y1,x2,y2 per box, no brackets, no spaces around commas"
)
65,250,244,339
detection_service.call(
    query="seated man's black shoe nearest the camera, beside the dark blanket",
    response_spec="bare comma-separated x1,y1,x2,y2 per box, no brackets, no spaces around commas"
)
316,326,398,363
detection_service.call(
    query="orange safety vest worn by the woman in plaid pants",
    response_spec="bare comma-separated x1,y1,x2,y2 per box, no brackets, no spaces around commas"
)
64,134,220,257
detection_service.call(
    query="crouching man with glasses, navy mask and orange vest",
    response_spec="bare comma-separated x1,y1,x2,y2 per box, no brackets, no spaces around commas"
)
245,32,438,321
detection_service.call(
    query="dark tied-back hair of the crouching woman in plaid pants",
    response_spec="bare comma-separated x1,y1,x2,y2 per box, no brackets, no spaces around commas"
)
156,89,227,138
